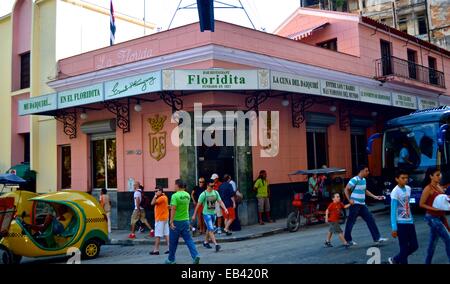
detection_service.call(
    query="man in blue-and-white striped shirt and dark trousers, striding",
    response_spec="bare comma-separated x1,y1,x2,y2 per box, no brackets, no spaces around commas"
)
344,165,387,245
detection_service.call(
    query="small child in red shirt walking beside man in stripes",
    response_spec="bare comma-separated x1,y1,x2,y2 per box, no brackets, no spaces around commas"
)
325,193,350,248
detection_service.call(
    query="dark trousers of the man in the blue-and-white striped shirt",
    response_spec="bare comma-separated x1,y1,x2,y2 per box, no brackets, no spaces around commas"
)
344,204,380,242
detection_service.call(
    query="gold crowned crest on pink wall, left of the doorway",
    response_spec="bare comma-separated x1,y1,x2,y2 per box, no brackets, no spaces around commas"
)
147,114,167,161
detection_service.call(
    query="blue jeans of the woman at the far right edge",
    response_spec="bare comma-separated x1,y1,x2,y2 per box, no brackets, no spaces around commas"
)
425,214,450,264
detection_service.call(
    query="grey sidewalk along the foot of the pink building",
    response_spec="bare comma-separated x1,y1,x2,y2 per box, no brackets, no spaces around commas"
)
108,203,387,246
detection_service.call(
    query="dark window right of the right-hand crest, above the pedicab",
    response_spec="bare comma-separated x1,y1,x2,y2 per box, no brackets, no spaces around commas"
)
306,130,328,169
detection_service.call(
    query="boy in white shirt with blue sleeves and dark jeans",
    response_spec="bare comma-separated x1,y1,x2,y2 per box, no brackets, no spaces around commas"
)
388,170,419,264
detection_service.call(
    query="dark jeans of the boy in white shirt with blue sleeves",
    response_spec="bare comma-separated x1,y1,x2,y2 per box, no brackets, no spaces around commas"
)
394,224,419,264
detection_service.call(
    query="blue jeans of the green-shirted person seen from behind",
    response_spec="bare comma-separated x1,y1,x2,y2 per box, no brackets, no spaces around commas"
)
169,221,199,262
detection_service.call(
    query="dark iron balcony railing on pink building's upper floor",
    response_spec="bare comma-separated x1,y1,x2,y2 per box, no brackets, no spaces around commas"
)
375,56,445,88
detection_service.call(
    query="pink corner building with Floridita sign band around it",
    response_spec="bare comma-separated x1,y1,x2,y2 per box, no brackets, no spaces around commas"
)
19,9,450,228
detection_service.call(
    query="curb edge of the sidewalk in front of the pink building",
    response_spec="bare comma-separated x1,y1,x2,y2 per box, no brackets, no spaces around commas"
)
106,228,287,246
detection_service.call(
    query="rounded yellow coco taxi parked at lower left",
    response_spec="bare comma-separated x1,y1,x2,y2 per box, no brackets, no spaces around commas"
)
0,190,108,263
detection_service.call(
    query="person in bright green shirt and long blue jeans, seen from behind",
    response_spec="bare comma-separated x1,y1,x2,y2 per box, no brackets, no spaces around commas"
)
166,179,200,264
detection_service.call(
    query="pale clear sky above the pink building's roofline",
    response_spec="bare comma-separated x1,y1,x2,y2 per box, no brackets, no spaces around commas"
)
0,0,300,32
